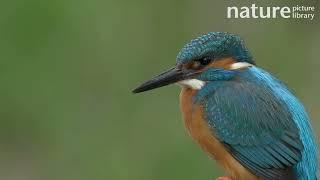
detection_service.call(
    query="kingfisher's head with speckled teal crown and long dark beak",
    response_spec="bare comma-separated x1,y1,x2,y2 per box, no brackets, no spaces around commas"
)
133,32,255,93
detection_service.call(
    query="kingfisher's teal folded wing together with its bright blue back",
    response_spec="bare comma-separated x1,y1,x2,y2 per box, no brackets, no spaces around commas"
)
195,67,318,180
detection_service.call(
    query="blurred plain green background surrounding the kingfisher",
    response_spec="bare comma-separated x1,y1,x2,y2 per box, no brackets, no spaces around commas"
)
0,0,320,180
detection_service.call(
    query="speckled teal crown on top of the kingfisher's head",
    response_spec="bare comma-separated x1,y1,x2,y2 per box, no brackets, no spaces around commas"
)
177,32,255,64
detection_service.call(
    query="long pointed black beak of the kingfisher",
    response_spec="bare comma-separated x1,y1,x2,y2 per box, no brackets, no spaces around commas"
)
132,67,194,93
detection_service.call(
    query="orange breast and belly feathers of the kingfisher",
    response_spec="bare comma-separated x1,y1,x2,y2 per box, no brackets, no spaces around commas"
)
180,88,257,180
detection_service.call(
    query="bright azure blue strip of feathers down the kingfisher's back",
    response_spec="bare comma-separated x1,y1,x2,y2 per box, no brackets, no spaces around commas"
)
252,68,319,180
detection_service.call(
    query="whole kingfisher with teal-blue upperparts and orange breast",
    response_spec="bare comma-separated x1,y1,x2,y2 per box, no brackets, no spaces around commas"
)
133,32,318,180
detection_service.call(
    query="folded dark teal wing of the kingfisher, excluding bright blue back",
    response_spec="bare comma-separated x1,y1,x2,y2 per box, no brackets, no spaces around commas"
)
202,78,303,179
